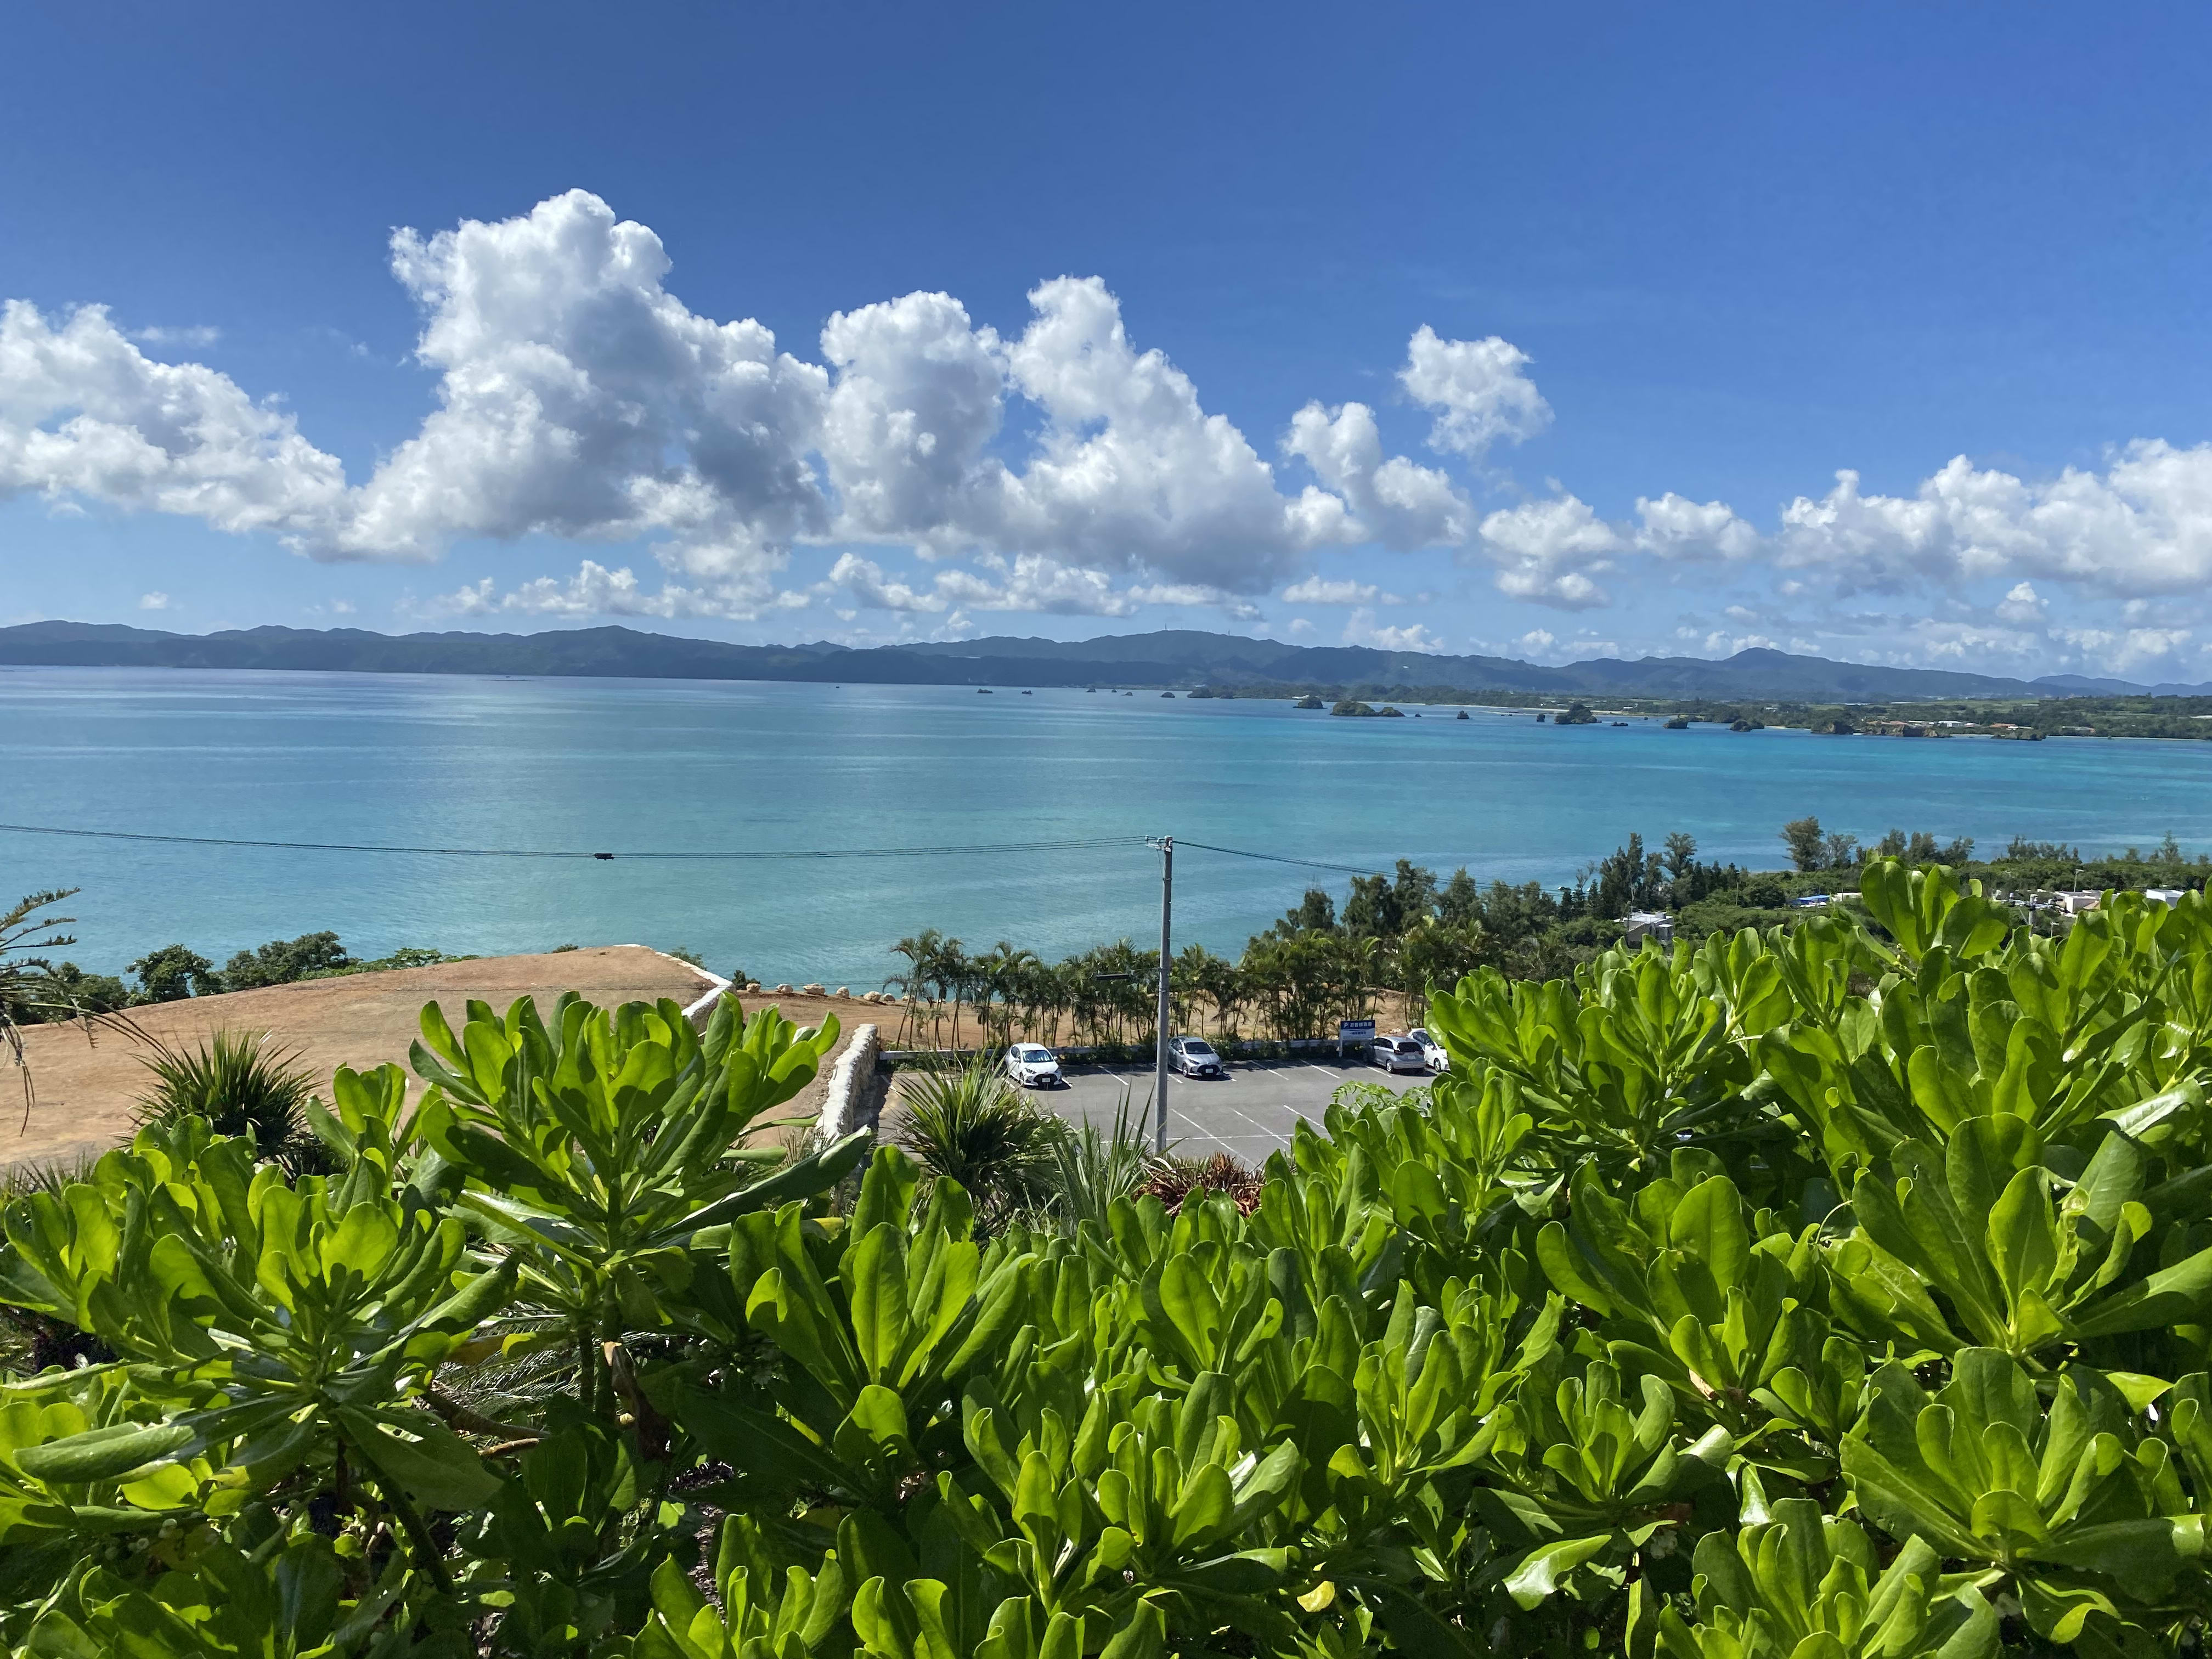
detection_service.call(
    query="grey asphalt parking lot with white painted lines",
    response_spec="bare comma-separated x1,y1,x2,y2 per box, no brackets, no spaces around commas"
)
1031,1057,1429,1166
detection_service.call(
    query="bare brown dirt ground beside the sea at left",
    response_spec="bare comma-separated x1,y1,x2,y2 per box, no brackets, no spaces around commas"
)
0,945,898,1166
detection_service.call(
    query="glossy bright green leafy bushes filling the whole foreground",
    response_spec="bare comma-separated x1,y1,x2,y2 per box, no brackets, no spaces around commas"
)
0,860,2212,1659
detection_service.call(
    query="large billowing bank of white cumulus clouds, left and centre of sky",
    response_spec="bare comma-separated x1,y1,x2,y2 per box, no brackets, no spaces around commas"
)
0,190,1550,617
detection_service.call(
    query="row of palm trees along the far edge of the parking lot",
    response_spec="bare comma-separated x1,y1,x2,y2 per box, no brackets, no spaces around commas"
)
885,918,1493,1048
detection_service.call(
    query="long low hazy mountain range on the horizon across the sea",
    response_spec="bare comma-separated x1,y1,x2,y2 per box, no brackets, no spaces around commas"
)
0,622,2212,703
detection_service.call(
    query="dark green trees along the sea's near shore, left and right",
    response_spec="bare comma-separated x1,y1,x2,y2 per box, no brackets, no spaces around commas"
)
13,816,2212,1051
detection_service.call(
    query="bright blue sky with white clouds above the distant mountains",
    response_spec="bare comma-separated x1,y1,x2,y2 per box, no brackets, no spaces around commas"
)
0,4,2212,681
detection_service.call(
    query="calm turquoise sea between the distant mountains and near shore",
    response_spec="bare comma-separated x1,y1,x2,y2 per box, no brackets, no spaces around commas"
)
0,668,2212,989
